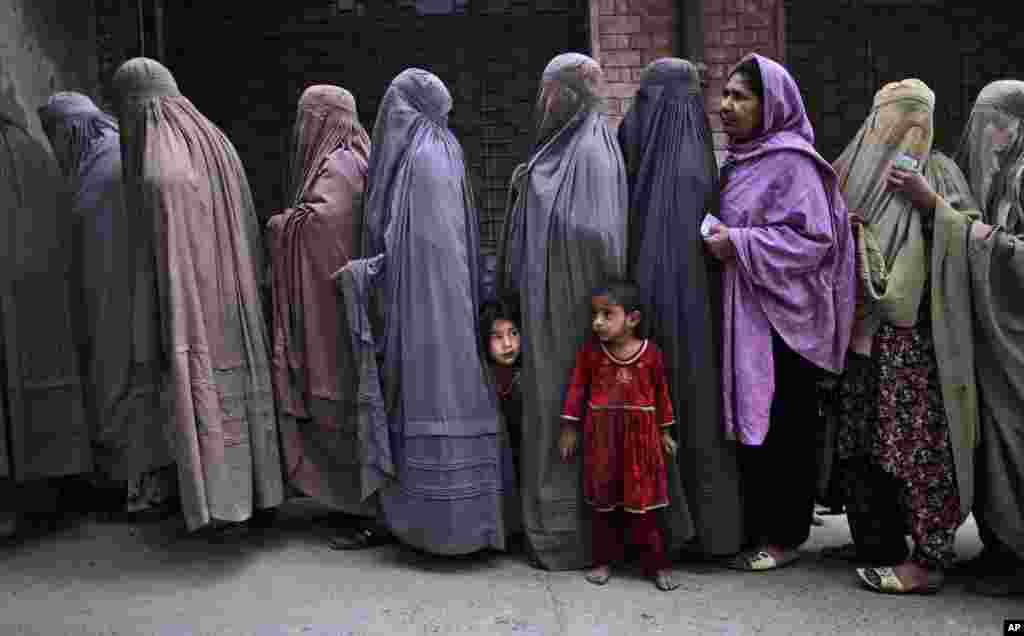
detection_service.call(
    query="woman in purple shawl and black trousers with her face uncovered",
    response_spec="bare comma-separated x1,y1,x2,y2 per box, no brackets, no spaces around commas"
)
707,54,854,570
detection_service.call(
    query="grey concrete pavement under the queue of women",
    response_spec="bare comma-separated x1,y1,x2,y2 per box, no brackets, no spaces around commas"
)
0,505,1024,636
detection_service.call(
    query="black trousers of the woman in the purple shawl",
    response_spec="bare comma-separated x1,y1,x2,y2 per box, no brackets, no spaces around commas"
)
739,331,822,549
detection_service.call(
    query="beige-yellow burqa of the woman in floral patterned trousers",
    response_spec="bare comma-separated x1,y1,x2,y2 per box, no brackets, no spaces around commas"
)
835,79,978,517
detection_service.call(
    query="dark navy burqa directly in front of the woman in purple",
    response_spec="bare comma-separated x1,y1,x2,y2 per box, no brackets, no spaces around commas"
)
618,58,742,554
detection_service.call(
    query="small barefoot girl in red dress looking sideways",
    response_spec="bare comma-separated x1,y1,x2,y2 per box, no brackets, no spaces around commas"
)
559,281,678,591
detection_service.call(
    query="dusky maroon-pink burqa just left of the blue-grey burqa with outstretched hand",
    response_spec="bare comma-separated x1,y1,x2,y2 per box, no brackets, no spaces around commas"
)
267,85,373,514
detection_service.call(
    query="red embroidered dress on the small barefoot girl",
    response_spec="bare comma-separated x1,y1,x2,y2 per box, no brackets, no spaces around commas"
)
562,340,674,513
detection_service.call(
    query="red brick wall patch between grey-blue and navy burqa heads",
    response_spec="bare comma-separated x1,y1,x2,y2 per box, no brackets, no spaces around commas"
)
591,0,680,126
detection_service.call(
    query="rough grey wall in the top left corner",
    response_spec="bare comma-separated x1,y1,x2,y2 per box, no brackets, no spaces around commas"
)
0,0,98,143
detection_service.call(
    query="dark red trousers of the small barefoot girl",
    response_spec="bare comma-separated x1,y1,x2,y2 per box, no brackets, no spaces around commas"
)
593,510,670,577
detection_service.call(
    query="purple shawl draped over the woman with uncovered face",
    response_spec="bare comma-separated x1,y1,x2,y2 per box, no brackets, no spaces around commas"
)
721,54,855,446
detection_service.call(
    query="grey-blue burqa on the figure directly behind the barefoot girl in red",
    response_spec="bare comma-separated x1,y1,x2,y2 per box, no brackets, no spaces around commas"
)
498,53,629,569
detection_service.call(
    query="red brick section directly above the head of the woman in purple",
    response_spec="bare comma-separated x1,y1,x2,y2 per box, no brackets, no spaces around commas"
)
703,0,785,155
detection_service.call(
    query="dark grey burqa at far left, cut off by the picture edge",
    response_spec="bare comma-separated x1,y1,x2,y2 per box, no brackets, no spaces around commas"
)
0,113,92,485
